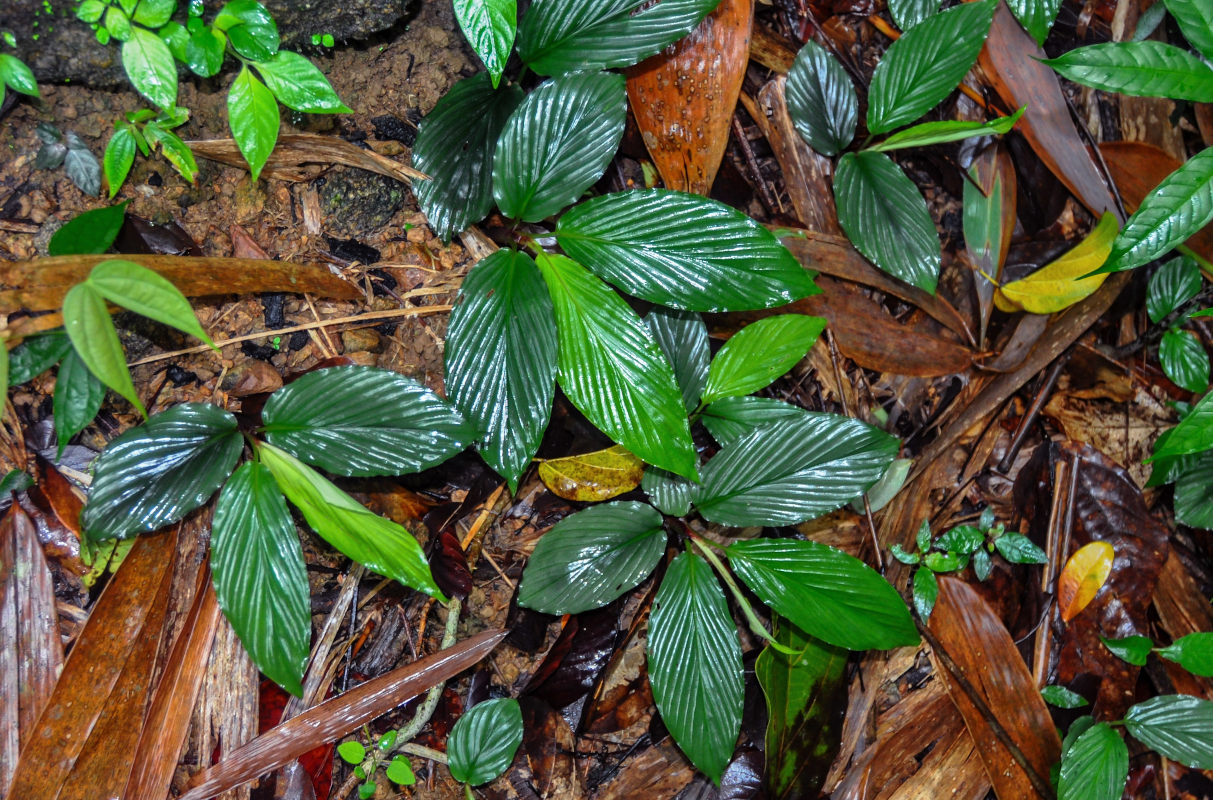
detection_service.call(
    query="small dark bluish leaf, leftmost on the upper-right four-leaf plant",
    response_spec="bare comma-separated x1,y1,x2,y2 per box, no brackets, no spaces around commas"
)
785,40,853,155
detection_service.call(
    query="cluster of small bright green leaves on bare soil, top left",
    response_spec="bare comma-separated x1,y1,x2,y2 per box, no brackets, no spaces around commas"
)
76,0,349,196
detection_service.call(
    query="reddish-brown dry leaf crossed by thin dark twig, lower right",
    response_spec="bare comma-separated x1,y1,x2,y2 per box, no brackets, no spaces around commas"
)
930,577,1061,798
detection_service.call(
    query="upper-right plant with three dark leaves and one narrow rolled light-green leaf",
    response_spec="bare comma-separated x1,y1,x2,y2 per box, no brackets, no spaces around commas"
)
786,0,1023,293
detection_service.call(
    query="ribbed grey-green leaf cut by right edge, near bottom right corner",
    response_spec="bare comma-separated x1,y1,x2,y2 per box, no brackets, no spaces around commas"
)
1124,695,1213,770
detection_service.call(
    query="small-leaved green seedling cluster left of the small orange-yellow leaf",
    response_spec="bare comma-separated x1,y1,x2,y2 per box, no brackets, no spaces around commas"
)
890,508,1048,622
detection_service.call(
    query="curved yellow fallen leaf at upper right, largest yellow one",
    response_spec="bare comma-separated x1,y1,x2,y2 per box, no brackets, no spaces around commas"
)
993,213,1120,314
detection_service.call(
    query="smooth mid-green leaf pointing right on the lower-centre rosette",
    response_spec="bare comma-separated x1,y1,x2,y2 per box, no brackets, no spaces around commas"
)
725,538,922,650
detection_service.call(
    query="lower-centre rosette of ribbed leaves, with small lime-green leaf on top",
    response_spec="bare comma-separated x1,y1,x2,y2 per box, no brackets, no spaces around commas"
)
518,309,918,782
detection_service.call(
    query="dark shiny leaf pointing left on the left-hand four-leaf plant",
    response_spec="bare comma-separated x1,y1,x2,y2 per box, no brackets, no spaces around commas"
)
81,402,244,539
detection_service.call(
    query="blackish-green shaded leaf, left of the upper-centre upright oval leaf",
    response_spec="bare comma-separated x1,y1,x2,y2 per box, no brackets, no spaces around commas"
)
412,73,523,241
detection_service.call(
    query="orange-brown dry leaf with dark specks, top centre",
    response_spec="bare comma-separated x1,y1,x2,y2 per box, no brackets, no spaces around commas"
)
627,0,753,195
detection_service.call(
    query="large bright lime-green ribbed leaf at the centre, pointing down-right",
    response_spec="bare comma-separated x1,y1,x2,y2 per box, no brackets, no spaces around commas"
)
536,255,699,479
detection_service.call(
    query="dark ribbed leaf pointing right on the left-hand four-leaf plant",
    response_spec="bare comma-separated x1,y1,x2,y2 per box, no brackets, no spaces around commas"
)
262,366,473,476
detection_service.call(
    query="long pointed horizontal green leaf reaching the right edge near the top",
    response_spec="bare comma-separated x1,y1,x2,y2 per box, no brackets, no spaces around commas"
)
1043,40,1213,103
